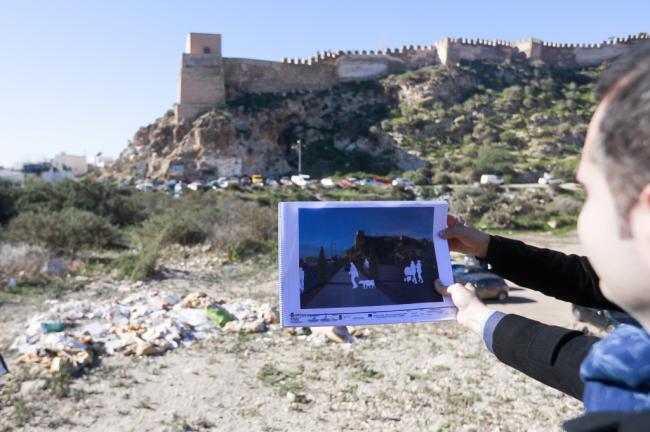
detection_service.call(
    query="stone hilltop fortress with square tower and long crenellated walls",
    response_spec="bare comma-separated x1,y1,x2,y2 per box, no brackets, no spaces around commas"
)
175,33,650,123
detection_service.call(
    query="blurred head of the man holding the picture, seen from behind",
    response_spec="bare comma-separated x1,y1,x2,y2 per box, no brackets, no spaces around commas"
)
578,46,650,330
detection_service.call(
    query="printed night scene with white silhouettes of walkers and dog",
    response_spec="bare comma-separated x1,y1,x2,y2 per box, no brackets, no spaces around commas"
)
298,207,442,309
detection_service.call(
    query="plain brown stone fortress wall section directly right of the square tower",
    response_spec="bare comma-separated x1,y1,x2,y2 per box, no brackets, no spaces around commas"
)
223,58,338,99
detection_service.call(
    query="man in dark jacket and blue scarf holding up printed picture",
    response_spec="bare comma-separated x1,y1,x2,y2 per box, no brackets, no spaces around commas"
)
437,48,650,431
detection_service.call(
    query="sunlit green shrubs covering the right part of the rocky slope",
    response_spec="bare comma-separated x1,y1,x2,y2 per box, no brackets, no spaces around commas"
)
380,61,602,183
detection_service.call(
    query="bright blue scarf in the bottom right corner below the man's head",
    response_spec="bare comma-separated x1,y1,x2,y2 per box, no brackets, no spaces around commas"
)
580,324,650,413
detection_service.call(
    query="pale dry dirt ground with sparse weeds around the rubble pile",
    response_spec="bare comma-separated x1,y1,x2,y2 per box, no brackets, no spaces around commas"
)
0,234,582,431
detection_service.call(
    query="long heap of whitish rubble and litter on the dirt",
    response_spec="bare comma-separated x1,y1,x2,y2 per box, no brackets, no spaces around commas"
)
12,291,278,372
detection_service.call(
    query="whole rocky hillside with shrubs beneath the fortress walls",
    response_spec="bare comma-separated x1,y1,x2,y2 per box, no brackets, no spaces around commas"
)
112,60,602,183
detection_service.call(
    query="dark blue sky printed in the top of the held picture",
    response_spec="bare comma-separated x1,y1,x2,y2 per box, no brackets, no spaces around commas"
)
298,207,433,257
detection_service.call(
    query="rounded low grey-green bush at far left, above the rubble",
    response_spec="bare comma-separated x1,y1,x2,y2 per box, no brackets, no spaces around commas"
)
7,208,119,255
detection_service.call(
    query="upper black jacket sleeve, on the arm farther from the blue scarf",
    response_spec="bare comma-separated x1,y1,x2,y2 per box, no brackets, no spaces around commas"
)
485,236,621,310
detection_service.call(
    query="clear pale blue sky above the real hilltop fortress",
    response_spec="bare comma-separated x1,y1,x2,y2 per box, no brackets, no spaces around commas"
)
0,0,650,166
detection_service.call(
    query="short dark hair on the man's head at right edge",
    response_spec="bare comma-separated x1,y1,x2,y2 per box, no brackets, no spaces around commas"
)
596,43,650,215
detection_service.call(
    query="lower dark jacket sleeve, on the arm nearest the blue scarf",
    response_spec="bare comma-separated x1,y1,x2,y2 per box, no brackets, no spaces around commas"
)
492,314,599,400
